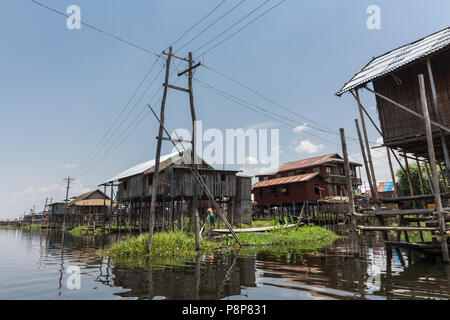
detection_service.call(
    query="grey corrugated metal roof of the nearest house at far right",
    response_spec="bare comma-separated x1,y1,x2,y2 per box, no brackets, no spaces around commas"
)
336,27,450,96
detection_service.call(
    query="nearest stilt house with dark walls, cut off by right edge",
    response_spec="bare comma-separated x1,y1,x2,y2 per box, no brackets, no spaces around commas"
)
337,24,450,261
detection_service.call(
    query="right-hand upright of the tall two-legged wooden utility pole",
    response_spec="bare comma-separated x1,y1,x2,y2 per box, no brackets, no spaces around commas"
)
188,52,200,250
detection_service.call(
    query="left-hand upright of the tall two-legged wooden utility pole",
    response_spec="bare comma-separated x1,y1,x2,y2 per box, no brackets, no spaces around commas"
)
147,47,172,252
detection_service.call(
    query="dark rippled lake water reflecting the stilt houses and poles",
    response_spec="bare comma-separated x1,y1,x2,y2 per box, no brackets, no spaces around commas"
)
0,230,450,300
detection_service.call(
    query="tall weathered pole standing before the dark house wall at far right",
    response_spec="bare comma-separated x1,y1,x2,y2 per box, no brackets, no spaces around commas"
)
419,74,449,262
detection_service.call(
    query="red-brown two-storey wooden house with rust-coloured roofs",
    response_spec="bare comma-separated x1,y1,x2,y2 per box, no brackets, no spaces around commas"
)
252,153,361,207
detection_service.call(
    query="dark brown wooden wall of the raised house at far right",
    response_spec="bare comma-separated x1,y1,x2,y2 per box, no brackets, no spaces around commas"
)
373,51,450,143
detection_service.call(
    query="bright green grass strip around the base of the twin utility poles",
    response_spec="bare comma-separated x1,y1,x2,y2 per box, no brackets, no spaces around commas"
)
105,226,339,262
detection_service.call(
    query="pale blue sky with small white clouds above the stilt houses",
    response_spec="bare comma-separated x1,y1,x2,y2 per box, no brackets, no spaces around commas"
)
0,0,450,219
